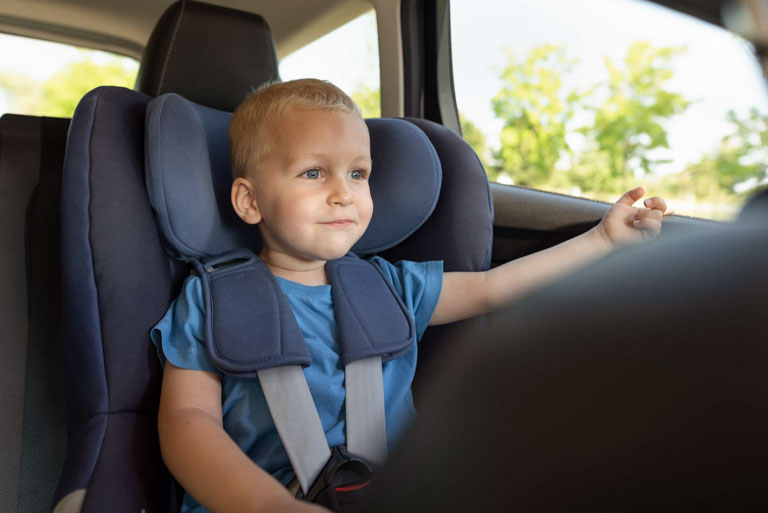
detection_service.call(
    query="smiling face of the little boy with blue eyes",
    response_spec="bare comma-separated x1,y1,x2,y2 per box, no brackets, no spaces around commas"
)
250,109,373,261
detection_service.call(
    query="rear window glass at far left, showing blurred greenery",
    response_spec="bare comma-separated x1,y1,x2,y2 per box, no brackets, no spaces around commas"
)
0,34,139,117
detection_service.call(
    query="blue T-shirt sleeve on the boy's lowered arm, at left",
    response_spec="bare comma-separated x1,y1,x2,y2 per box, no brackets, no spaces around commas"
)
150,276,221,375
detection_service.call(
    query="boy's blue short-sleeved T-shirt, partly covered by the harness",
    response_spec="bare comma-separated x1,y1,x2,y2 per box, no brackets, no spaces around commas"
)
151,257,443,511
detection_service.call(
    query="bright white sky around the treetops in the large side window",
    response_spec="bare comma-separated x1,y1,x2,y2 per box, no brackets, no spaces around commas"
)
451,0,768,170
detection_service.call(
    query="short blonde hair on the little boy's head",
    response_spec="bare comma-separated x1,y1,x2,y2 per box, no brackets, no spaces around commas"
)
229,78,362,178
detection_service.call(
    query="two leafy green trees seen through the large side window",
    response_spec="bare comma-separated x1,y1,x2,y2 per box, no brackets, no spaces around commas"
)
491,42,688,193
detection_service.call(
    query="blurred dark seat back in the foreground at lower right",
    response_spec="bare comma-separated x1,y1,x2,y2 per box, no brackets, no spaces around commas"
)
371,211,768,513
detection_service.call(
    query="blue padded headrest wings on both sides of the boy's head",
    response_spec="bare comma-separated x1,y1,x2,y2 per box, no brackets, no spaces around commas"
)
145,94,442,260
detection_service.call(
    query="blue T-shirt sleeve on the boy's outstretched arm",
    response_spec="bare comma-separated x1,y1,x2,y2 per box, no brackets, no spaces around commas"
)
370,257,443,340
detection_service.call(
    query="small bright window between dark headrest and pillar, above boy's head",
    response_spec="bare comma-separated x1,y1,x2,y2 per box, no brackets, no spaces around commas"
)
280,10,381,117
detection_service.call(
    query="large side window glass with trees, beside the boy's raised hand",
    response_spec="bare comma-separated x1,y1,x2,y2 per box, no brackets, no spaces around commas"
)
451,0,768,219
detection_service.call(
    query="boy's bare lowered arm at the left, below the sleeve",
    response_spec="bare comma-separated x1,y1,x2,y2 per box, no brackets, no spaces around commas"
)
158,362,328,513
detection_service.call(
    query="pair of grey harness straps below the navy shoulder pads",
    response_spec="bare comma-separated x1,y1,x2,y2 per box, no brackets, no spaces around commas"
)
258,356,387,493
